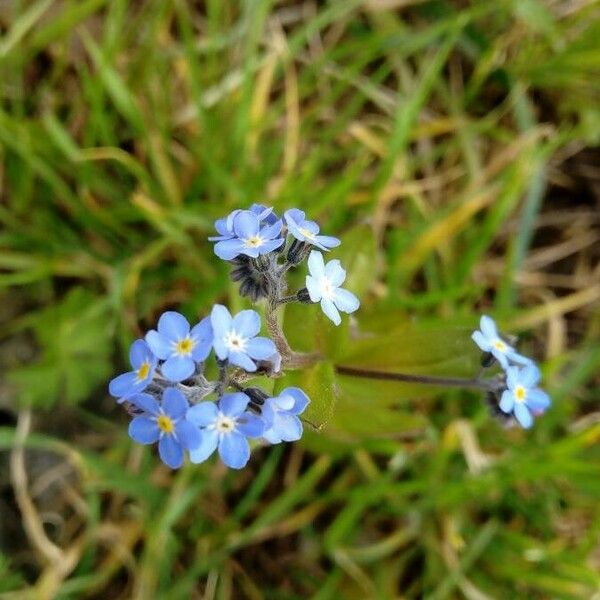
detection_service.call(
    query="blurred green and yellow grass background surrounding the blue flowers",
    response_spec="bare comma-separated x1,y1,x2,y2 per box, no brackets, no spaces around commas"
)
0,0,600,600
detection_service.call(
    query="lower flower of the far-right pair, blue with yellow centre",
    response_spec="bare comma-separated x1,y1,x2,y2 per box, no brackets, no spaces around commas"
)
500,364,550,429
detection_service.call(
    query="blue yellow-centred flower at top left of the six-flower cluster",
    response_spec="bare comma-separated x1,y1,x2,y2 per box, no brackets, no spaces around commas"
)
146,311,213,382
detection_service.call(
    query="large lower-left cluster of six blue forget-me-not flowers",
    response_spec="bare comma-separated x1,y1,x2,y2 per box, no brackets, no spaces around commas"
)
109,304,309,469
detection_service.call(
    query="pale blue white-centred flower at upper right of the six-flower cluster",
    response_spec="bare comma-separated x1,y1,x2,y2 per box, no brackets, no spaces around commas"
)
210,304,277,371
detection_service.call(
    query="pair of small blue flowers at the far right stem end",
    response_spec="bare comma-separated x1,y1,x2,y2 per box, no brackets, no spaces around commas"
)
472,315,550,428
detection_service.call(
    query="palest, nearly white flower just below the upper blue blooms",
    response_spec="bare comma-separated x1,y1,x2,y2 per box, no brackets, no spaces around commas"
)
306,250,360,325
